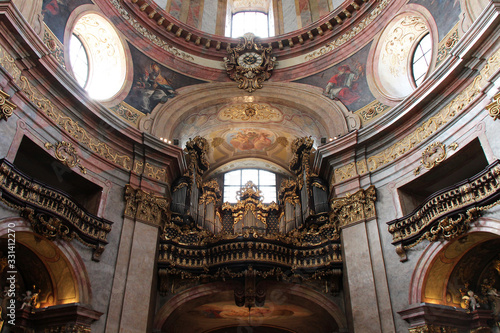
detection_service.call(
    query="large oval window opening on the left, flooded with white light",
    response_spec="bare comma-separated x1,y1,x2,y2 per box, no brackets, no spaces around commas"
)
69,13,127,101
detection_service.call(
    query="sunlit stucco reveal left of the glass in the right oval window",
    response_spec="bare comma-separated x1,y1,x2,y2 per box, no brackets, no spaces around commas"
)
381,16,428,77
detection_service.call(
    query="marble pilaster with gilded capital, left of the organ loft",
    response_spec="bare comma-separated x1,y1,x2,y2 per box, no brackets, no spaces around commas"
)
106,185,169,333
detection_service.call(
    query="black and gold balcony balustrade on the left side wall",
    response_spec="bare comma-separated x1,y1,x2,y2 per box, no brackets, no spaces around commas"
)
0,159,112,261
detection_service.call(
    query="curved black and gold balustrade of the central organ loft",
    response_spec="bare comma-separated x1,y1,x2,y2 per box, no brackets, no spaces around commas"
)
158,223,342,293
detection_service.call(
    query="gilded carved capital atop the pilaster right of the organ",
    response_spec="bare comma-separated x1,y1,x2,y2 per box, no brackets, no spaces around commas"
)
330,185,377,227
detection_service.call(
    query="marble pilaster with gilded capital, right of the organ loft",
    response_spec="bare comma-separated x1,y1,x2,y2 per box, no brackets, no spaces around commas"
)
331,186,396,333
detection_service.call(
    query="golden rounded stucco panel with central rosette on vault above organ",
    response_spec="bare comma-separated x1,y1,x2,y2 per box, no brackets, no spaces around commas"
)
217,103,283,123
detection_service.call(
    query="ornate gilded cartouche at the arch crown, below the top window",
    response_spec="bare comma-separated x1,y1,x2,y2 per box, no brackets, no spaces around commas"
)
224,33,276,93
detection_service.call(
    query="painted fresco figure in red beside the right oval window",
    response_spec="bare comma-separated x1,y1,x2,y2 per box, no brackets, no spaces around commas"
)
324,65,361,105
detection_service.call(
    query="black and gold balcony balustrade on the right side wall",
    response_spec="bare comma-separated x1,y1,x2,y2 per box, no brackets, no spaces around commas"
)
387,160,500,261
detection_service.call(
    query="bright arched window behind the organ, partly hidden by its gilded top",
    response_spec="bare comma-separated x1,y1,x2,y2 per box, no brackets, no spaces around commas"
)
223,169,277,203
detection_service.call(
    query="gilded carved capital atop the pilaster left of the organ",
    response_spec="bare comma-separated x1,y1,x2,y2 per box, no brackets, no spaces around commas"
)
124,185,171,227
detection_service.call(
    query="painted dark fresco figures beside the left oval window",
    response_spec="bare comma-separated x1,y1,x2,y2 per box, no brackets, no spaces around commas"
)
132,62,177,113
